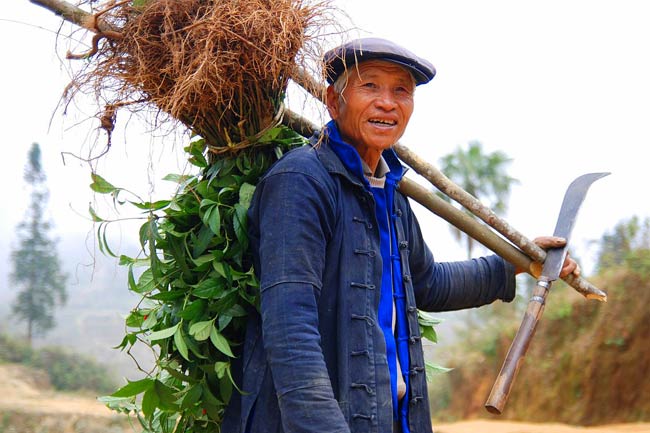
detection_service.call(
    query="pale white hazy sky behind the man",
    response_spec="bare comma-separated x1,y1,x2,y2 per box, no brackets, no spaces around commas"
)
0,0,650,286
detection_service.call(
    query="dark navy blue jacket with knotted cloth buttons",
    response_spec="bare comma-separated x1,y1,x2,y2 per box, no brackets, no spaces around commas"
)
221,137,515,433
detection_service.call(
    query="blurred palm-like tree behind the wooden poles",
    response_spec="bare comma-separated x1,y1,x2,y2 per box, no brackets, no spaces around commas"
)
440,141,517,258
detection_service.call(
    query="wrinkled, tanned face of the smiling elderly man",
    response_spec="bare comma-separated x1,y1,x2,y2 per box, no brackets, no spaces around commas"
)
327,60,415,155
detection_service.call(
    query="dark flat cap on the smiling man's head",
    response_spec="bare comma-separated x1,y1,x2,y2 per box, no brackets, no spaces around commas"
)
323,38,436,85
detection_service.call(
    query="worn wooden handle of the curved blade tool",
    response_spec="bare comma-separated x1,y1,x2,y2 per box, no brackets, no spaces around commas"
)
485,281,550,415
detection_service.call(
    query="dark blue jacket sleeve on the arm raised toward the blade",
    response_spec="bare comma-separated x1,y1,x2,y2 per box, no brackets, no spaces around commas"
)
406,196,515,312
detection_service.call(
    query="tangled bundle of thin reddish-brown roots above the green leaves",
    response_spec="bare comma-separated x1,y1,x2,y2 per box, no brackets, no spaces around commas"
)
72,0,333,151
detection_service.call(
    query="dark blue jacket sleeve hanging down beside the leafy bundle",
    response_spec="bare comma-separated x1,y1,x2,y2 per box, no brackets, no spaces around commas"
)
253,172,349,433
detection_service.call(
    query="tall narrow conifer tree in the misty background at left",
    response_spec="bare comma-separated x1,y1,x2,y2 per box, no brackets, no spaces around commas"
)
9,143,66,344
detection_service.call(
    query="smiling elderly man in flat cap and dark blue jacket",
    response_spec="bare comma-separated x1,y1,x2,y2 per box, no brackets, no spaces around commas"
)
222,38,576,433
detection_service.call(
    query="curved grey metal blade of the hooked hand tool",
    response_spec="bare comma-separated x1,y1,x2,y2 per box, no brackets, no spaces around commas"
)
542,173,609,281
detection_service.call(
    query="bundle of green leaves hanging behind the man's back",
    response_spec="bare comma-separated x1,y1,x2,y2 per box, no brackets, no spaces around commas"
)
95,126,305,433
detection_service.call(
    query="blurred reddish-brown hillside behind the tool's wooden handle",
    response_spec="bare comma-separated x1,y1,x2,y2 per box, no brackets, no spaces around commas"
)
439,264,650,425
